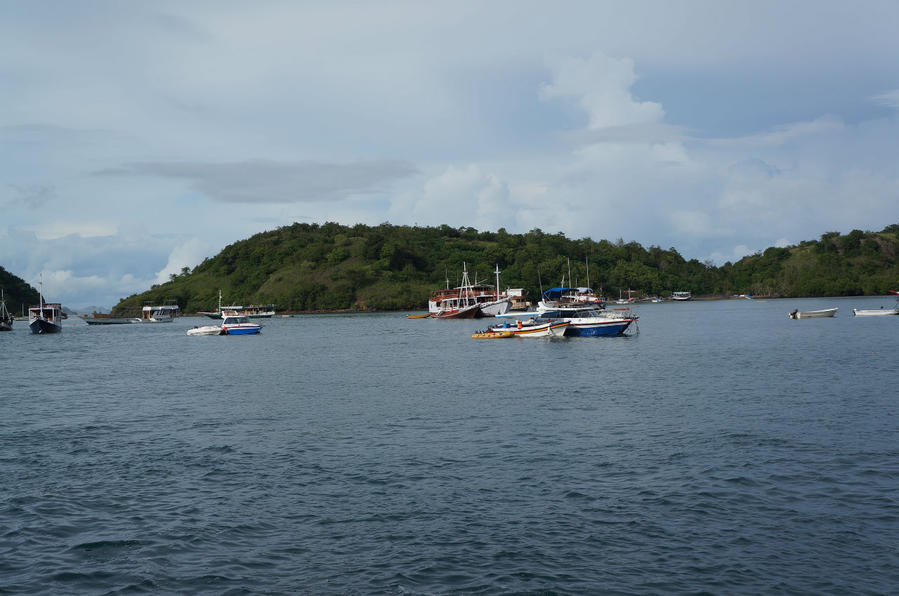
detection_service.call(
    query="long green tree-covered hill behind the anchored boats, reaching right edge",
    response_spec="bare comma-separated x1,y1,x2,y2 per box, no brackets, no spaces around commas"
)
114,223,899,313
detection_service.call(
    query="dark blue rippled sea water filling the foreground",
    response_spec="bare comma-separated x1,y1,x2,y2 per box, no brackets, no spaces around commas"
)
0,299,899,594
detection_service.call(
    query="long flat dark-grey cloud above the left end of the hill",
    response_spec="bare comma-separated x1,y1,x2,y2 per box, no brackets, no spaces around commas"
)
98,160,418,203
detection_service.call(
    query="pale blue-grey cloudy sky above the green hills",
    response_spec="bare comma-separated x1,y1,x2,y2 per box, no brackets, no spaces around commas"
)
0,0,899,310
